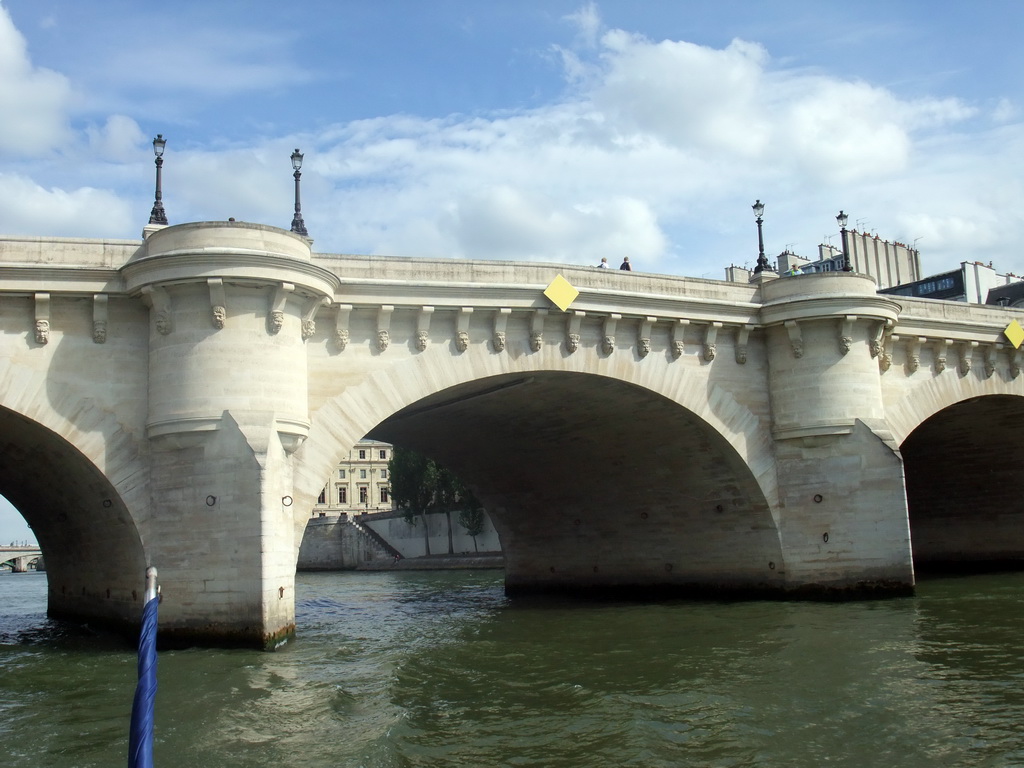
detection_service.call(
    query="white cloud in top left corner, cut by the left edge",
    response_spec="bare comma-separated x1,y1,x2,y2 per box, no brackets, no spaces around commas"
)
0,6,71,157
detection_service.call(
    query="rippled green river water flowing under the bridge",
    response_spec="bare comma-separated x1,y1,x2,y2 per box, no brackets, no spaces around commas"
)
0,571,1024,768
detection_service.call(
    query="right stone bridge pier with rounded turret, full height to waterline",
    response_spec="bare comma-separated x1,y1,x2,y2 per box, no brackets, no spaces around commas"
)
762,273,913,593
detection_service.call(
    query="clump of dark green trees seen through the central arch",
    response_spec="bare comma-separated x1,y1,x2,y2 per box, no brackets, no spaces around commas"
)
388,445,482,555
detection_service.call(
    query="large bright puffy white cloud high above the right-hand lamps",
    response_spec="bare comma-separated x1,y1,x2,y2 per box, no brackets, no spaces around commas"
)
589,30,973,189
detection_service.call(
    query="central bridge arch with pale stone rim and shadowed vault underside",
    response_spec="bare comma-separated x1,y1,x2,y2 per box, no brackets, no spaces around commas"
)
296,344,784,591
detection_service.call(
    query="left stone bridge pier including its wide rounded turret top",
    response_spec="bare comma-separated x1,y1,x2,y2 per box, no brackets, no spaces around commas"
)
124,222,337,648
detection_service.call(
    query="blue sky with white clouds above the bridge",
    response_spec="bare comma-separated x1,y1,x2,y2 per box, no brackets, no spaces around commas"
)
0,0,1024,542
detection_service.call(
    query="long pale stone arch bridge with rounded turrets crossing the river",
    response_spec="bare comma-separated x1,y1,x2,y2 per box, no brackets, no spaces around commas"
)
0,221,1024,647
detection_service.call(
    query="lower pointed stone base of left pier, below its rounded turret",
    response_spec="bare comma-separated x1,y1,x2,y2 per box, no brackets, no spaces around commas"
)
146,411,298,648
